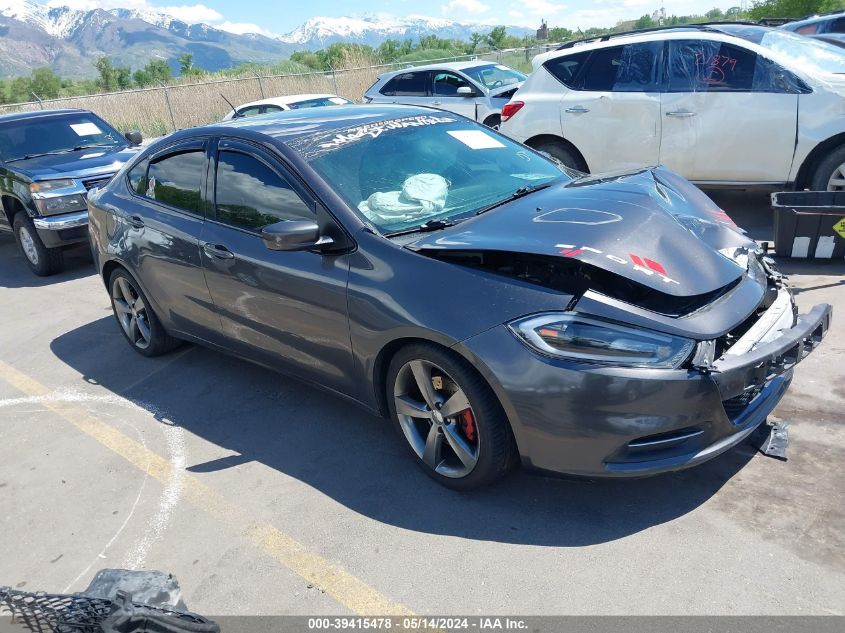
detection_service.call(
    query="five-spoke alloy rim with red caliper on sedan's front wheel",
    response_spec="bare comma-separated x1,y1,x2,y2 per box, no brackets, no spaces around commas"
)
393,360,480,478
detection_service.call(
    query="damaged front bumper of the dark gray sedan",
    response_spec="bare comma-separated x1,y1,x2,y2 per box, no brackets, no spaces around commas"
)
457,304,831,477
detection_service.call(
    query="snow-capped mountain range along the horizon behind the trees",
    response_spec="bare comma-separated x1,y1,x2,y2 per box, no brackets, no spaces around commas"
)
0,0,528,78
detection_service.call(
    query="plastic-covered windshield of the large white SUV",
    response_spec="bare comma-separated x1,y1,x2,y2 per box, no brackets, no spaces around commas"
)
726,27,845,74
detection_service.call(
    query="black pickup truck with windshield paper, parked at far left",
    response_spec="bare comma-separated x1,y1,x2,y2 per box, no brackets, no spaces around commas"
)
0,110,141,276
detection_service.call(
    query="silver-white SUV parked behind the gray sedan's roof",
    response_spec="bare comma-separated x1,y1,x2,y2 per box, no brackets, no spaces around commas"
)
364,61,525,128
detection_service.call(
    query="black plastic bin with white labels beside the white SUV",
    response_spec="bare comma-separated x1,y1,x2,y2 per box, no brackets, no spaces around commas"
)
772,191,845,259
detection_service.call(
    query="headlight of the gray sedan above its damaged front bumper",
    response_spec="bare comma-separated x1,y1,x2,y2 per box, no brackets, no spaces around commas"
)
508,312,695,369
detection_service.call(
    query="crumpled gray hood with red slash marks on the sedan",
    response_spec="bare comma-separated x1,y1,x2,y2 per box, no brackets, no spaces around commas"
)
407,167,756,297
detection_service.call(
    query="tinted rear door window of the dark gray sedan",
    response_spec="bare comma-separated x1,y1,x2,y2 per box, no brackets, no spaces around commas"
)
143,148,206,215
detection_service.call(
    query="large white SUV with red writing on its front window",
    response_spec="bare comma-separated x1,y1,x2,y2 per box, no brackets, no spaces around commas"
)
501,24,845,190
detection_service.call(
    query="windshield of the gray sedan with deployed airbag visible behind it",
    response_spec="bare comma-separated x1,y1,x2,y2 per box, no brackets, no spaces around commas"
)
288,114,570,234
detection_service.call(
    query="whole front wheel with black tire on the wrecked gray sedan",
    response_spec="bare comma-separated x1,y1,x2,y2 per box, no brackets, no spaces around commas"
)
386,343,516,490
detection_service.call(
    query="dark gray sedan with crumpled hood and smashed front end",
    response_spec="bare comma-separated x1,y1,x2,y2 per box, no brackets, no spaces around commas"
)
89,105,831,488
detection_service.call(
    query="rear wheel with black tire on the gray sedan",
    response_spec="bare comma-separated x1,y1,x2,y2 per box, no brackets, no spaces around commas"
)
109,268,181,357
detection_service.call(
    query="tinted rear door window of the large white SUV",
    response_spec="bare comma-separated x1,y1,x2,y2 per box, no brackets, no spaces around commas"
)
583,42,663,92
